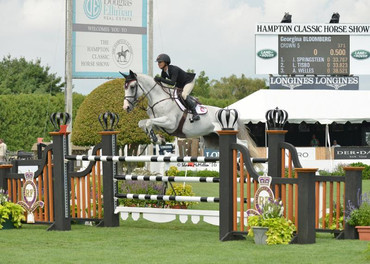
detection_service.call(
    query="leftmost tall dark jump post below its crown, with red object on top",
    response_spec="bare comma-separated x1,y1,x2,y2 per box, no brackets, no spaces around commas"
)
48,125,71,231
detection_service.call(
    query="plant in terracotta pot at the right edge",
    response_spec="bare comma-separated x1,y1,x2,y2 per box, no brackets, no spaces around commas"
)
346,193,370,240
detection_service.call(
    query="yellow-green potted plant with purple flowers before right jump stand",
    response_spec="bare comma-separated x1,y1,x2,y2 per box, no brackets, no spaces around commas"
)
248,198,296,245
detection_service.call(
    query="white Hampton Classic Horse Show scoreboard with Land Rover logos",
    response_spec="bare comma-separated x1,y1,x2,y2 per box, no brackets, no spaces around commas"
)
255,23,370,76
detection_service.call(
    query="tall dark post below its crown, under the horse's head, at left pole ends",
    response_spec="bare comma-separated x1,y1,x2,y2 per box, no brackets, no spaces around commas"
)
99,131,119,227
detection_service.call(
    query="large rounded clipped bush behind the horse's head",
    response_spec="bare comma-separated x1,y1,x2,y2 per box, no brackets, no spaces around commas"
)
72,79,150,155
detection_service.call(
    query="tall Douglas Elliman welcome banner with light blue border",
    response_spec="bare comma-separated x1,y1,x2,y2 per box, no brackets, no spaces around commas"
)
72,0,148,79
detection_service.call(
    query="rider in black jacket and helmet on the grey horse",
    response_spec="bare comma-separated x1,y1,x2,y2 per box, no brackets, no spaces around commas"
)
154,54,200,121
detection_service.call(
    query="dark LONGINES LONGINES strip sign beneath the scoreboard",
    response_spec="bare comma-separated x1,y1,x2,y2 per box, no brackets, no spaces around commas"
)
270,76,359,90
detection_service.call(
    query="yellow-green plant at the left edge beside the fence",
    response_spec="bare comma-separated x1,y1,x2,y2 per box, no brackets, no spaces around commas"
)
0,189,26,229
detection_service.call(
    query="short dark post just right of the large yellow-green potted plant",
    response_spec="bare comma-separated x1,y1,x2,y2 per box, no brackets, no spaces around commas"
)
295,168,318,244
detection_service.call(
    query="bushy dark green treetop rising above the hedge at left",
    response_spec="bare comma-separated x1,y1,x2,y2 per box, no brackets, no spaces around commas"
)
0,55,64,95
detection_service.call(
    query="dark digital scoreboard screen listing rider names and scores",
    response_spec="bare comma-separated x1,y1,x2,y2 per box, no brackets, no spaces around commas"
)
278,35,350,75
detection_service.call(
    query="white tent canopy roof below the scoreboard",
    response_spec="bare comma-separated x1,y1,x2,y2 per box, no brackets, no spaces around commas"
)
229,89,370,124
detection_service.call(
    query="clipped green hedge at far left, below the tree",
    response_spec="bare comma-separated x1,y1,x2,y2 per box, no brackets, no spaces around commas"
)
0,93,84,151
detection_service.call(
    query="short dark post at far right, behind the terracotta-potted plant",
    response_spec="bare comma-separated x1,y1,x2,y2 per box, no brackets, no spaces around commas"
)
343,167,365,239
